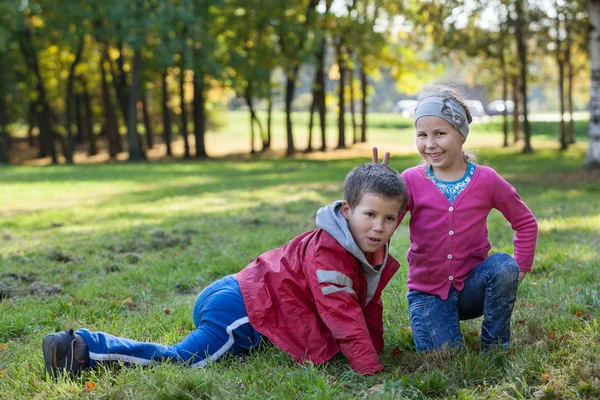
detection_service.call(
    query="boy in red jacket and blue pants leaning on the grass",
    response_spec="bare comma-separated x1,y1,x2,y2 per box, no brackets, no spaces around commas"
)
42,163,407,376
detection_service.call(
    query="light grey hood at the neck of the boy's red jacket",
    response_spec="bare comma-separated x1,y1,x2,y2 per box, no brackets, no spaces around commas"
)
317,200,388,303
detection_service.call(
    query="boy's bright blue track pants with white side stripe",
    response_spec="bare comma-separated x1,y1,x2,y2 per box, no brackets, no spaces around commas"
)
75,275,261,367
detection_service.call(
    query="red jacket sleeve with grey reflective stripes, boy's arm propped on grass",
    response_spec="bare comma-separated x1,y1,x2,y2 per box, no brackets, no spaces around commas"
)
304,245,383,375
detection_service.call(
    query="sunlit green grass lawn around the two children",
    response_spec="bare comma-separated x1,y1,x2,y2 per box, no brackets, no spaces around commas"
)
0,114,600,399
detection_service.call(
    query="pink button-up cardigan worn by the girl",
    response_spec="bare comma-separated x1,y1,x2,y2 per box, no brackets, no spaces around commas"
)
400,165,538,300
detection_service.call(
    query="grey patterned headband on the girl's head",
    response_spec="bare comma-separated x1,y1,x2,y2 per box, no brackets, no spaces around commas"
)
415,97,469,139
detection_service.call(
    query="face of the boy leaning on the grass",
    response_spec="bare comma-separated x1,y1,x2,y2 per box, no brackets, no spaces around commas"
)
342,193,402,253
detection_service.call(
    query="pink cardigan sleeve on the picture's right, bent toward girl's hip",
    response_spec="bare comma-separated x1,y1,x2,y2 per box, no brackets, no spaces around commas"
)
493,175,538,272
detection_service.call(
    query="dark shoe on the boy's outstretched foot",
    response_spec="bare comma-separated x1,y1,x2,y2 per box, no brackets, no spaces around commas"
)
42,329,89,378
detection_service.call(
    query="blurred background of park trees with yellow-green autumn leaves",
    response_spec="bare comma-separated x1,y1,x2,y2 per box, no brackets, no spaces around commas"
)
0,0,591,165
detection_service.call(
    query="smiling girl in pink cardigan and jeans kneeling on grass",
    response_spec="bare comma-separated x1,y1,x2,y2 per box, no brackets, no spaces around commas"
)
374,87,538,352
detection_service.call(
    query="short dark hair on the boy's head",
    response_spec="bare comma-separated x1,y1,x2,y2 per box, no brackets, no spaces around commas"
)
344,163,408,209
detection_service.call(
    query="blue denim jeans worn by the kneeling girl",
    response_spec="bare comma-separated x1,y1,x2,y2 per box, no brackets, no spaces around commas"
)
407,253,519,352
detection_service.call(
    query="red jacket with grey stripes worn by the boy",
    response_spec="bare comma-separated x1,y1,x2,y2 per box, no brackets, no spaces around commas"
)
236,229,400,375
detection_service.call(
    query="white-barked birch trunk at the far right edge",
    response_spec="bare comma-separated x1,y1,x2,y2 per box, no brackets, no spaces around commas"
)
586,0,600,168
